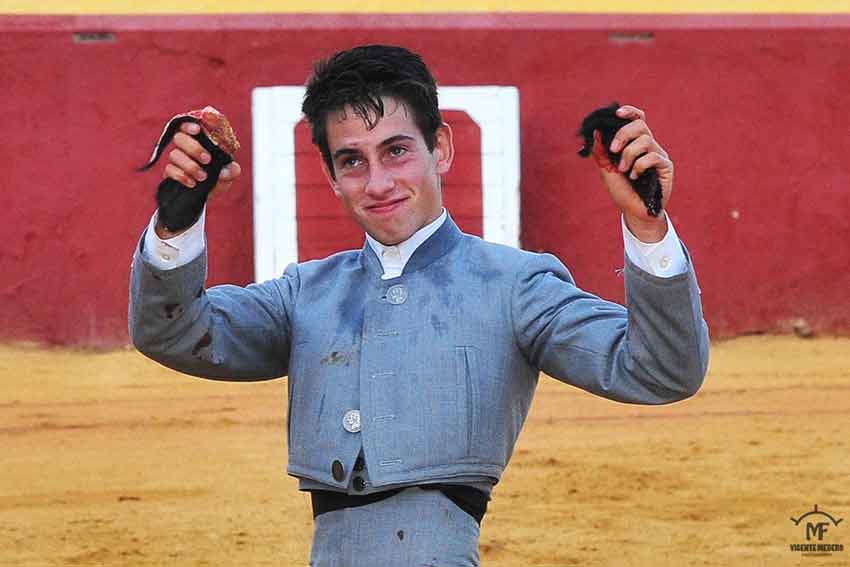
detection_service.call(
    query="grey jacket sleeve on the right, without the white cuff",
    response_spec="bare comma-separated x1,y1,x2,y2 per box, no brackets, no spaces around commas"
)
512,247,709,404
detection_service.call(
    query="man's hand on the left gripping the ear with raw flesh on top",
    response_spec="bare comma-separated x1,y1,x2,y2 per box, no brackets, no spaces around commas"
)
162,122,242,199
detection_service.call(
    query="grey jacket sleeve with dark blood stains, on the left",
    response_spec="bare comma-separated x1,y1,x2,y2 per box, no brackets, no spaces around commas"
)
129,231,298,380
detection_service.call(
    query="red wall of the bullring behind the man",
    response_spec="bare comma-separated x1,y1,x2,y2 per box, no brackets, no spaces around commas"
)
0,16,850,346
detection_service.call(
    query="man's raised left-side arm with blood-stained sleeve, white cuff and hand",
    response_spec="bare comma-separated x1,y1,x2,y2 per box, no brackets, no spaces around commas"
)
129,119,298,380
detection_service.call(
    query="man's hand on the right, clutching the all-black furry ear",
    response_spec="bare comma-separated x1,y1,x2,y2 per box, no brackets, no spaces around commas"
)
593,105,673,242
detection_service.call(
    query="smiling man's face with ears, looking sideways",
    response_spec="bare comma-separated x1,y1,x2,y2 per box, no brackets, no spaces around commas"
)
323,97,454,245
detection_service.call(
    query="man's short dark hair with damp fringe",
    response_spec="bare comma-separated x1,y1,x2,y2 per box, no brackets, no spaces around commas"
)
301,45,443,175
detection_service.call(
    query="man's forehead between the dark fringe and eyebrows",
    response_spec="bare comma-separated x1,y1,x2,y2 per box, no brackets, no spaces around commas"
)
327,97,424,153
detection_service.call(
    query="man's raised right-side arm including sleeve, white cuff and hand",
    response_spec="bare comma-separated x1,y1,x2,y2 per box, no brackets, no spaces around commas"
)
513,106,709,404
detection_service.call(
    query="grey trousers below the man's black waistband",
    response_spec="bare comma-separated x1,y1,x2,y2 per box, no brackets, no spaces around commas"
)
310,487,480,567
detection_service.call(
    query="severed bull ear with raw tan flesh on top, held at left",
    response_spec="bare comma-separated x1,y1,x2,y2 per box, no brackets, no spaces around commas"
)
138,106,239,232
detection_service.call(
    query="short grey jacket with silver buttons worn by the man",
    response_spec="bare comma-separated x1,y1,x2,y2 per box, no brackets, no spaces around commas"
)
130,218,708,489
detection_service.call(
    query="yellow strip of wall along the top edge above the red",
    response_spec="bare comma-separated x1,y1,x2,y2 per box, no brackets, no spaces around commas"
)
0,0,850,14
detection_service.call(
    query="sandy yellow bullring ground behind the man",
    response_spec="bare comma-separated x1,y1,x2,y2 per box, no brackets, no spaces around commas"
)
0,337,850,567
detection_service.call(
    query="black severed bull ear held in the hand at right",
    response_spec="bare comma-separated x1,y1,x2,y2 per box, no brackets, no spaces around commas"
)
578,102,662,217
